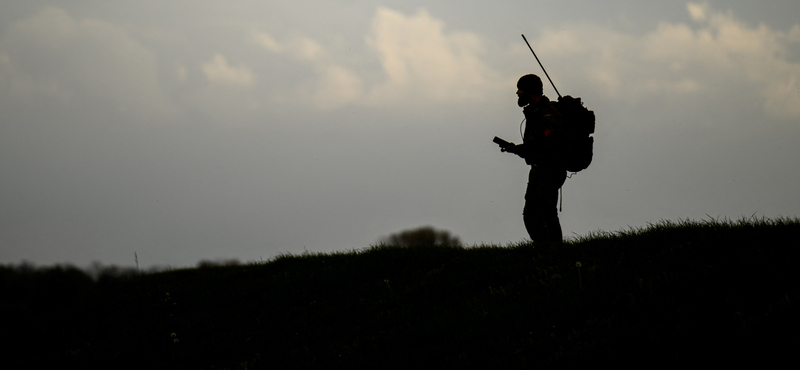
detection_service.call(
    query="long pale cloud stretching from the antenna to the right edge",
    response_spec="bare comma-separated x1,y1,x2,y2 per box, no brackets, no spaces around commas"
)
536,3,800,118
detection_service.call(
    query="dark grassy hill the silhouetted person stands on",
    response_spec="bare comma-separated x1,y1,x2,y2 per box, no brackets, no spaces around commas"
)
0,219,800,369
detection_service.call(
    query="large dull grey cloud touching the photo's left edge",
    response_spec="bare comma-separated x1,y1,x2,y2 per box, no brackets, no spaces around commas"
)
0,7,177,120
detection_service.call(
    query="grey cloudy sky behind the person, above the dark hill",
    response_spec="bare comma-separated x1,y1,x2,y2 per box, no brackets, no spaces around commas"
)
0,0,800,268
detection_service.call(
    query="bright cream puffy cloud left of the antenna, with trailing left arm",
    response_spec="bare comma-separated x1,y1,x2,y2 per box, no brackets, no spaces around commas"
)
253,7,508,109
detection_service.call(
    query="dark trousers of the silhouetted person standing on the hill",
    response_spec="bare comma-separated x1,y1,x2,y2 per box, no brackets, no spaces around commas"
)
522,166,567,243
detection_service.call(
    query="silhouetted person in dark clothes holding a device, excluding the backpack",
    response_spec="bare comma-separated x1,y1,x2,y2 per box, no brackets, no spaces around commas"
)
501,74,567,243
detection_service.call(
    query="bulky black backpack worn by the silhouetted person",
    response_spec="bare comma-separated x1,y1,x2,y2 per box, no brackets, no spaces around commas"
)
551,95,594,172
